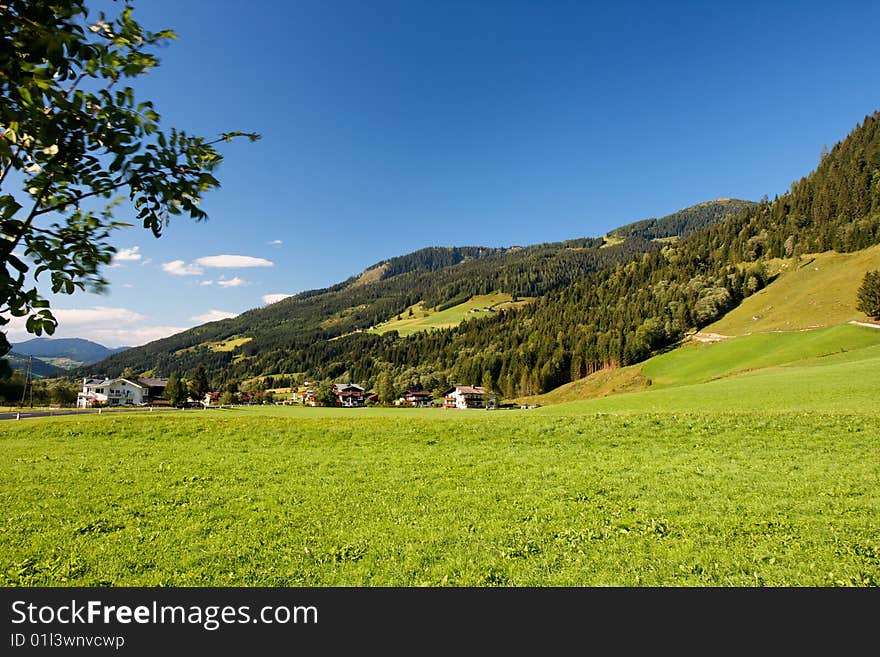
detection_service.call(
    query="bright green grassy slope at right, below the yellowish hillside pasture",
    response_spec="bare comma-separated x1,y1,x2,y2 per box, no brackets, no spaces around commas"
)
540,325,880,415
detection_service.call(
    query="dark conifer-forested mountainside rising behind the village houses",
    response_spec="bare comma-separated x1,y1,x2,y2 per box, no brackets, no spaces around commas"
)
82,114,880,396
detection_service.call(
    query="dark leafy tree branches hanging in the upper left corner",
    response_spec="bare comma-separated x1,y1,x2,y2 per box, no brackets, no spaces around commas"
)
0,0,258,355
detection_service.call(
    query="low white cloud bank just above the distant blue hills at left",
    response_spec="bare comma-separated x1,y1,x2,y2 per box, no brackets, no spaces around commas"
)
5,306,187,347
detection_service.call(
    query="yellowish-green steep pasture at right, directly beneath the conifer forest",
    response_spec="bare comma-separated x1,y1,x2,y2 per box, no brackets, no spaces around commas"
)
705,246,880,335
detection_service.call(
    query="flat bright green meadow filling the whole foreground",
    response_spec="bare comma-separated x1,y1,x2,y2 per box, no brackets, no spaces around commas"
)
0,394,880,586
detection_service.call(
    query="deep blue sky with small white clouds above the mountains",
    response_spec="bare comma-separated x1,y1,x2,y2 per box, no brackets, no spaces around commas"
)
10,0,880,346
